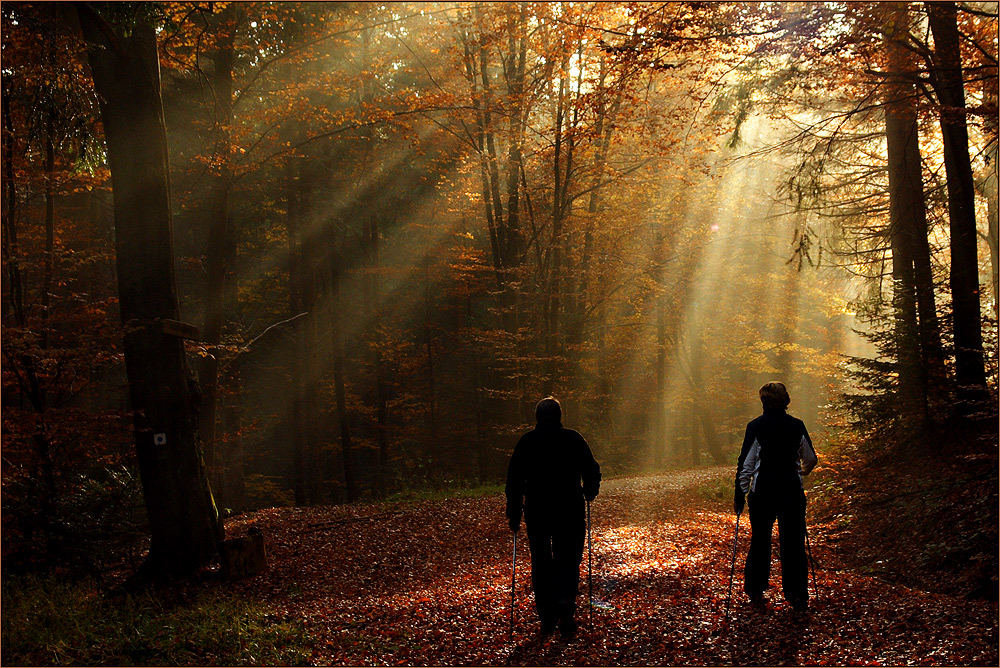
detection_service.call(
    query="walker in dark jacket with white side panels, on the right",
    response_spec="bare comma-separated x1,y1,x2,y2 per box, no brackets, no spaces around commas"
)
733,382,816,612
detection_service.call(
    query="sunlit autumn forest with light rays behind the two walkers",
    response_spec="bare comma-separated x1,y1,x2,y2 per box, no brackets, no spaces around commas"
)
0,2,998,580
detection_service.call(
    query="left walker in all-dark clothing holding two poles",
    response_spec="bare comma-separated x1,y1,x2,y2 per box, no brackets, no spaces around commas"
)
506,397,601,637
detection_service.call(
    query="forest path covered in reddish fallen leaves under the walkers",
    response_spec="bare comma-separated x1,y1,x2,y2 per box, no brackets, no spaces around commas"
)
227,467,998,666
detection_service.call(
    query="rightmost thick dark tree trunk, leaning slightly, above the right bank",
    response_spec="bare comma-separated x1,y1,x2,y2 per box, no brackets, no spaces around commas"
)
924,2,989,414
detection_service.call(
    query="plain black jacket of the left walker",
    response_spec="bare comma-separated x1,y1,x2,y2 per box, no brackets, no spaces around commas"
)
506,421,601,523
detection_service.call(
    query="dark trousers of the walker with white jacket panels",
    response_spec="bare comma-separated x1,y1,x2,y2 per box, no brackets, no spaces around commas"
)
743,490,809,602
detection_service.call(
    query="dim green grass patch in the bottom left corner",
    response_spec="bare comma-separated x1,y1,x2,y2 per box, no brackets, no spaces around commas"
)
0,577,309,666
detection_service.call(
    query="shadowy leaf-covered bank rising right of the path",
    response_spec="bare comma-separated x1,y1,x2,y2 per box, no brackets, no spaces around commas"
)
810,423,998,601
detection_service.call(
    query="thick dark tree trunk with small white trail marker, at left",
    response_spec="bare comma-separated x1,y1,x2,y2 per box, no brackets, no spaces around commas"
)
76,4,222,577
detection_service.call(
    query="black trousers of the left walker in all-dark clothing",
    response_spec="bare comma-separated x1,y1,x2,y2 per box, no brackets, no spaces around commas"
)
525,517,587,624
